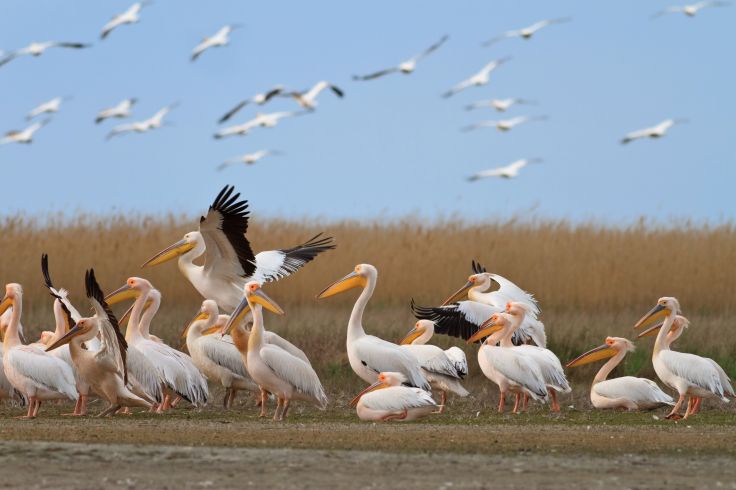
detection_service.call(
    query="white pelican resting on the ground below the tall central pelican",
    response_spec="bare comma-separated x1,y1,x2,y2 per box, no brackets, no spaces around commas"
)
350,373,442,422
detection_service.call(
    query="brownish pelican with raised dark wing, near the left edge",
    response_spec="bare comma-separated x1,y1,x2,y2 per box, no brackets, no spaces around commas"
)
46,269,151,417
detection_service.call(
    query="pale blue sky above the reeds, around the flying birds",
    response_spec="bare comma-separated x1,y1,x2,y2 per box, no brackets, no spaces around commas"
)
0,0,736,224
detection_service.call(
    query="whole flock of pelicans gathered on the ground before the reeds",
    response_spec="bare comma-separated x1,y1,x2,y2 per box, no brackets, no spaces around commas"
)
0,186,734,421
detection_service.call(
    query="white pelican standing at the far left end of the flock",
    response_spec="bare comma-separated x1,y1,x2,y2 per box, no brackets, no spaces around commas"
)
0,283,78,418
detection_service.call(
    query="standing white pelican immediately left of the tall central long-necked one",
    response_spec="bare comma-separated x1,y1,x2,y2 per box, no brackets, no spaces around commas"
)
223,281,327,420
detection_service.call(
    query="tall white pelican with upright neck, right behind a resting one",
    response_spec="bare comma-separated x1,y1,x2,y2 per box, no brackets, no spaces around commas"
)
317,264,430,391
